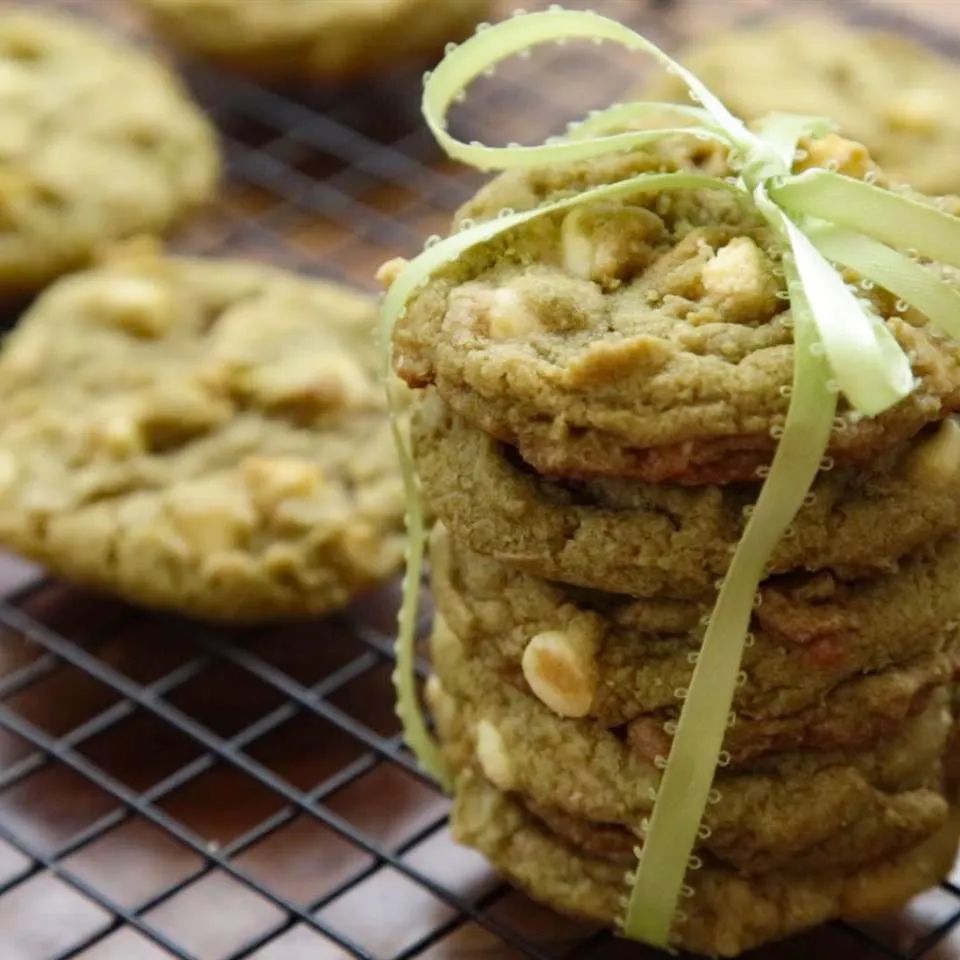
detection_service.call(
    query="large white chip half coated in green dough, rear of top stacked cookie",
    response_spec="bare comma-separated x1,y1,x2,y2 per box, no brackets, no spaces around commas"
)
560,203,664,286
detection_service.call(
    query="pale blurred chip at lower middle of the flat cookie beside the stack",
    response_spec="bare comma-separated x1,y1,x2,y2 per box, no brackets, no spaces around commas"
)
167,483,254,555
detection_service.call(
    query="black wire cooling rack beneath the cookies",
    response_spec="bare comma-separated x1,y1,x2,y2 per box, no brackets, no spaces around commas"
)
0,0,960,960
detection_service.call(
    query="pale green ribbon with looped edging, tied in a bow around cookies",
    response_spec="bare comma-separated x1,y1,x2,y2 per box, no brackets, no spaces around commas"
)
381,7,960,946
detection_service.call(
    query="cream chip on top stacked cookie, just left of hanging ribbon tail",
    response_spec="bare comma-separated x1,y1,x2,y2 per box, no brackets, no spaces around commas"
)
702,237,777,322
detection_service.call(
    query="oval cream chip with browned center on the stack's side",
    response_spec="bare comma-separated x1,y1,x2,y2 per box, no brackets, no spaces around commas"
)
521,630,597,717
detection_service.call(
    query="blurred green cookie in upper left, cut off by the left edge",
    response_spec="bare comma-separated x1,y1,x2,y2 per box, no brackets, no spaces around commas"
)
0,8,219,297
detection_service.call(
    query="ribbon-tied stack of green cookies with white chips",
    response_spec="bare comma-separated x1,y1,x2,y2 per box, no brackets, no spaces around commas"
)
394,136,960,956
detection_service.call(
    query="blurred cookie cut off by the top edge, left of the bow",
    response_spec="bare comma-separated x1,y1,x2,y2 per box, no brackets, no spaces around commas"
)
134,0,491,80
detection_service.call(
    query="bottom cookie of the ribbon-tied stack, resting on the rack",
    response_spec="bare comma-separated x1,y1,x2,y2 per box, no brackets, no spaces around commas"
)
452,771,960,957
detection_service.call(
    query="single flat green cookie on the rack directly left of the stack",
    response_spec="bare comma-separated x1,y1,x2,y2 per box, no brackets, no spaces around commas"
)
0,254,403,621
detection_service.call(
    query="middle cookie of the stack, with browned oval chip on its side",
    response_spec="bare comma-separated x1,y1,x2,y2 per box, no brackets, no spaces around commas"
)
431,527,960,744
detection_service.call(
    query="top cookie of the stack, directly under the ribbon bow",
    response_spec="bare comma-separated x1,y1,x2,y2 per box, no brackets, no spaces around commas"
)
394,129,960,484
